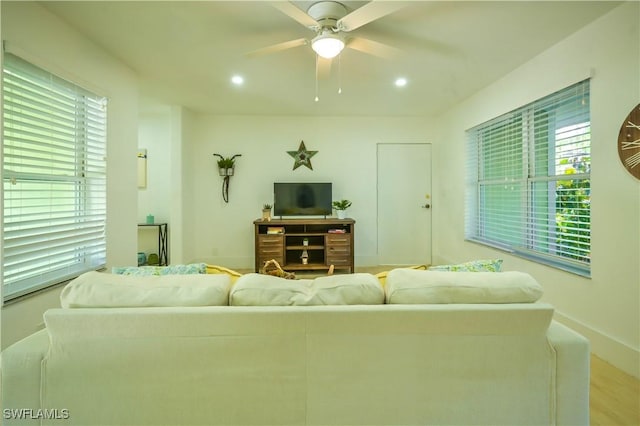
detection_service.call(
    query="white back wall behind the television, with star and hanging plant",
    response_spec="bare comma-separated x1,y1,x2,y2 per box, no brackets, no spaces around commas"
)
183,115,431,268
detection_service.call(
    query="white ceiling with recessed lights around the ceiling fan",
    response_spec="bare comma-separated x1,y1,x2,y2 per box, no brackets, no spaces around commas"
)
42,1,619,116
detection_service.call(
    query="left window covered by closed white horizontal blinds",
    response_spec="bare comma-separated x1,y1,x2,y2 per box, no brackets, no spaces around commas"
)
2,54,106,300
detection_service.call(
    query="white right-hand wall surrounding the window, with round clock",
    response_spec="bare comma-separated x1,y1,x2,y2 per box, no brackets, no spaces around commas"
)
434,2,640,377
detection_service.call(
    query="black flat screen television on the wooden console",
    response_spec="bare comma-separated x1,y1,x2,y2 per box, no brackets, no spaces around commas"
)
273,182,332,216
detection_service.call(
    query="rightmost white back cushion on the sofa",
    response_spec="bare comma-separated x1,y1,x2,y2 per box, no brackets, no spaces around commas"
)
385,269,542,304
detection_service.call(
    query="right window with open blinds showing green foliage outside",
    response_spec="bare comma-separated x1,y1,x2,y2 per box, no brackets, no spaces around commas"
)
465,80,591,276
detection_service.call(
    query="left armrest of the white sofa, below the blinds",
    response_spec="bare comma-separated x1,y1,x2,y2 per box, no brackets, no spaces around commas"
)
0,330,49,425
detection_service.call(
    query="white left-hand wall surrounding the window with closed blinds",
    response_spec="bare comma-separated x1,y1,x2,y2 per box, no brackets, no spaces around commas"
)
1,2,138,347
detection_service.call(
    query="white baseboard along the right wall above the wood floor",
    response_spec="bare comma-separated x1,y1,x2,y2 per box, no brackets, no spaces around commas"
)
554,311,640,378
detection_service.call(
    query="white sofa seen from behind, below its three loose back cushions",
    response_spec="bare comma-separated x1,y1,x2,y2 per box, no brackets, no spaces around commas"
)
2,271,589,425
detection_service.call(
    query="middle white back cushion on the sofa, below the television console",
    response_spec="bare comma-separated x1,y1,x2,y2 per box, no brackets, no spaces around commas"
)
229,273,384,306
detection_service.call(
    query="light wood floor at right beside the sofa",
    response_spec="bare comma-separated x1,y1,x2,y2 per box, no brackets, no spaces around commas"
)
589,355,640,426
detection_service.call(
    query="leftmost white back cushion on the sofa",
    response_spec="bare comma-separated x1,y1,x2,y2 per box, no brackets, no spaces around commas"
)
60,272,231,308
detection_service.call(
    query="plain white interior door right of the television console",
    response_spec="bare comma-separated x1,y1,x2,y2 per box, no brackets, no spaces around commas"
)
378,143,431,265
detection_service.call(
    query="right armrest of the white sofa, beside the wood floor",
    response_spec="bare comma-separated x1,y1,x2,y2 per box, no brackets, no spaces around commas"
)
547,321,590,425
